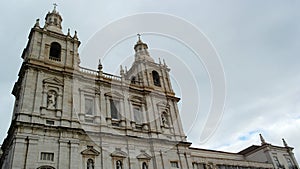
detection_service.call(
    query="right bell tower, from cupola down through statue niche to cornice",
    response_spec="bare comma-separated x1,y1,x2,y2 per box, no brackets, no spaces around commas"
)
124,34,186,141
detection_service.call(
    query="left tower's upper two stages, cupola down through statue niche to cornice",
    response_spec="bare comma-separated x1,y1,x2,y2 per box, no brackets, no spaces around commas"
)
12,4,80,124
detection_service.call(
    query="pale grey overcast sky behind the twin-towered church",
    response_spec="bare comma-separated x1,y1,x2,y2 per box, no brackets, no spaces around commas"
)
0,0,300,162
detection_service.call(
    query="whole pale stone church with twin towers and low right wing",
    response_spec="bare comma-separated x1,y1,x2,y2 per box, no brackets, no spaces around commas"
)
0,8,298,169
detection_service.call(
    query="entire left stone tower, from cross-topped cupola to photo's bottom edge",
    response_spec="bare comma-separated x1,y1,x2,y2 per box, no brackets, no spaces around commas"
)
0,4,82,168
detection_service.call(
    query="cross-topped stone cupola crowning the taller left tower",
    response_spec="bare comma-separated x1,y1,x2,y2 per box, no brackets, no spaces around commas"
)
45,4,62,33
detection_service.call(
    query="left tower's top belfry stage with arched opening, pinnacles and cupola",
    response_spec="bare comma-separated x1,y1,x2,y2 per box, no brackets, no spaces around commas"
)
22,4,80,71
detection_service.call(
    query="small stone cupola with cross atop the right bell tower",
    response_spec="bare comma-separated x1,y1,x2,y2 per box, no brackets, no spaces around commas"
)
134,34,154,62
